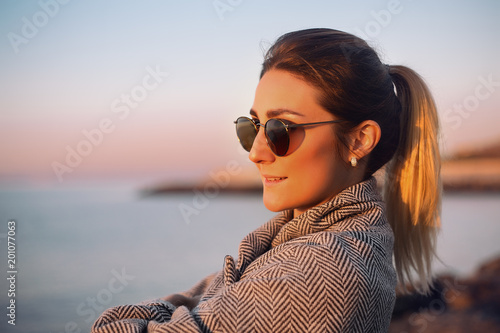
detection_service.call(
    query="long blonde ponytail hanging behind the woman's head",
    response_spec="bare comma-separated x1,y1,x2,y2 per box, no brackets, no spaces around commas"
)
384,66,441,292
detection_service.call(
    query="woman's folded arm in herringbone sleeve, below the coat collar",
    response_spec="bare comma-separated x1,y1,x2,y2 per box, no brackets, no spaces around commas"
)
92,239,394,333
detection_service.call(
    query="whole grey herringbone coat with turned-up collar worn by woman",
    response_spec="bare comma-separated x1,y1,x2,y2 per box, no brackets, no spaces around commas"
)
93,178,396,333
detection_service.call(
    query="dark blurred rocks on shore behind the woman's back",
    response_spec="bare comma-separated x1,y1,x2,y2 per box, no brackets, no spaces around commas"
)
389,257,500,333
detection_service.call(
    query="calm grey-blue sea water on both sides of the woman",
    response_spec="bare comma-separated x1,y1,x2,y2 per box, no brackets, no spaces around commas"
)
0,185,500,333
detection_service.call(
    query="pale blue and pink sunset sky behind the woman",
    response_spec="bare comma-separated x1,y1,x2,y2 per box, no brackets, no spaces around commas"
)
0,0,500,187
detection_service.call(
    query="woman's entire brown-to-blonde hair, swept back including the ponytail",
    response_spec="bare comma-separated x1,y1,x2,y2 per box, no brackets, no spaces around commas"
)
260,29,441,292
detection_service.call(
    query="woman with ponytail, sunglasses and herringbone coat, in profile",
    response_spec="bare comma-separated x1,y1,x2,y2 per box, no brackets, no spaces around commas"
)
93,29,440,332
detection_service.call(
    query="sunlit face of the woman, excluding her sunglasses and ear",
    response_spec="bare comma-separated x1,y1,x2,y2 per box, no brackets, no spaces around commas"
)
249,70,352,216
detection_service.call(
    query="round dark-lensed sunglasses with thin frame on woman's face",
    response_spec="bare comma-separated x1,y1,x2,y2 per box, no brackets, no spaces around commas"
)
234,117,342,156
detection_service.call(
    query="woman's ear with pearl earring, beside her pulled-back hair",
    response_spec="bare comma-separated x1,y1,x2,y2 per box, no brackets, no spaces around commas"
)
348,120,382,161
